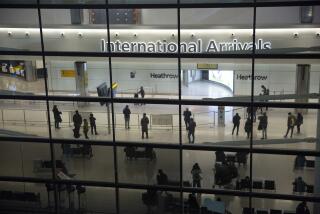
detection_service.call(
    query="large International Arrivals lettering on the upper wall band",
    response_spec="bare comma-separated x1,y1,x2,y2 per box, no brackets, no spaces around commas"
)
101,39,271,53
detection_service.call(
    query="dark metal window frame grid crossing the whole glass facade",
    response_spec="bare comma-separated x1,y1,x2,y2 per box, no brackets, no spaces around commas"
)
0,0,320,213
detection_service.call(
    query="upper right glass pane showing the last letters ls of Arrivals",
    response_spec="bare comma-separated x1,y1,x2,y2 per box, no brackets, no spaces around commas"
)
256,7,319,54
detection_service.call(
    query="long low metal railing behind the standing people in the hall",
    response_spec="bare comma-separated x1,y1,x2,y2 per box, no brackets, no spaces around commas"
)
0,107,246,130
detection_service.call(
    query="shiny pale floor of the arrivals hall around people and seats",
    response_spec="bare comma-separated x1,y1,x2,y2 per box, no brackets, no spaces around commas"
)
0,101,316,213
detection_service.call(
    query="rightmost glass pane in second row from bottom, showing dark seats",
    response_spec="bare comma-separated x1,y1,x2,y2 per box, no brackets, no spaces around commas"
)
252,154,317,195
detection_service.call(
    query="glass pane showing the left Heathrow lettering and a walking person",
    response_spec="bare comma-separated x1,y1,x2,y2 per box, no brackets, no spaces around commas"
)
112,58,179,99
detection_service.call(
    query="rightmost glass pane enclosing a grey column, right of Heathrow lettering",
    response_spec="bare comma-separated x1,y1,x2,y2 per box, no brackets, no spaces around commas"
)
254,59,320,103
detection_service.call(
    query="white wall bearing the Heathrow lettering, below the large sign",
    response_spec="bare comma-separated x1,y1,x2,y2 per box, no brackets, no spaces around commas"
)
49,61,320,95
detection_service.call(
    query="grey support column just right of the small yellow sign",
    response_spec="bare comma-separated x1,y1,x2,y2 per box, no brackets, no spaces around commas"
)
74,62,89,105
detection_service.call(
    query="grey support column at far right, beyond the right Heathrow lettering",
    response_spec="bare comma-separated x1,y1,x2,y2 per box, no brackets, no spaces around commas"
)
295,64,310,113
